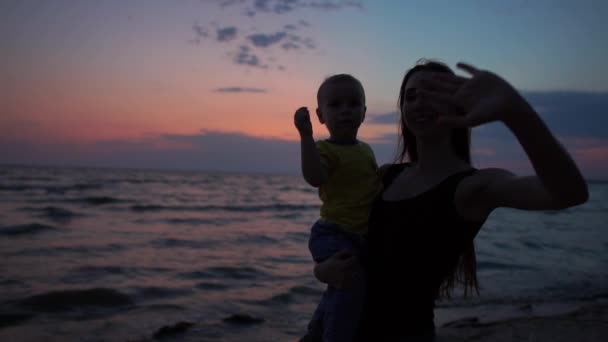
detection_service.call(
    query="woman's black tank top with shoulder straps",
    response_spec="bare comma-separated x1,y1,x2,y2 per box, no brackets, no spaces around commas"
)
362,164,483,341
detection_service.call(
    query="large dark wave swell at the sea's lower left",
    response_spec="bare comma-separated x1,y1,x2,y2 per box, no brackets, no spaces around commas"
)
19,288,133,311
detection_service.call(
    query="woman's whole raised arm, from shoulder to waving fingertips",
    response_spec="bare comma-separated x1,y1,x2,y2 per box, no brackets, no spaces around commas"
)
428,64,588,219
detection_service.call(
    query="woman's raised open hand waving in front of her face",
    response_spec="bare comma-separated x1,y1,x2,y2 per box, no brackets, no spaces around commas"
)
423,63,530,127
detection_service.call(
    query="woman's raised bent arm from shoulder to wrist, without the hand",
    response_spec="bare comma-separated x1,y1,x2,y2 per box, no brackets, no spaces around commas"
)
463,108,589,213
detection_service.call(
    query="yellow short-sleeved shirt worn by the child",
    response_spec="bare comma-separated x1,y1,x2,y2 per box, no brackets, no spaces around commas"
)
316,140,382,234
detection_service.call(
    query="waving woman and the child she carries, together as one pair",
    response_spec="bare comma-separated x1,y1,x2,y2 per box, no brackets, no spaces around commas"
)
294,60,588,342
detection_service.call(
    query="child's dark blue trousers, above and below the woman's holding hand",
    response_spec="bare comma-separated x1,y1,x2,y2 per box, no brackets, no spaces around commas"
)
308,221,365,342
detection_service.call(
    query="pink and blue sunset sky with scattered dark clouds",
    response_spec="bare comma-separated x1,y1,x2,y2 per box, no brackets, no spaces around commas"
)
0,0,608,179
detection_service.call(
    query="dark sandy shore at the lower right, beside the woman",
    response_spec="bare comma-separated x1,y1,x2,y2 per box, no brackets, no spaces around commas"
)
437,300,608,342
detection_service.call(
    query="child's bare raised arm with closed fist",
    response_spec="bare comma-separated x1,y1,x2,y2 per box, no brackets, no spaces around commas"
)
294,107,327,187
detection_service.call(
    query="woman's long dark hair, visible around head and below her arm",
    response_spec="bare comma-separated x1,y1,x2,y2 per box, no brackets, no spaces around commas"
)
395,59,479,298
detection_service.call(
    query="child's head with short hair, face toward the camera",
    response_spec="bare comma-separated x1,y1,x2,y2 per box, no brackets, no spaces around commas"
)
317,74,367,142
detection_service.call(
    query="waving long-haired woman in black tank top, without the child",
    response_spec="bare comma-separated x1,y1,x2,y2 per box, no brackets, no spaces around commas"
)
306,61,588,341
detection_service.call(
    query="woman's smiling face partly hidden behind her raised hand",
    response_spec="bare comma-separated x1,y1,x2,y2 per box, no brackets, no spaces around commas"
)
401,71,450,138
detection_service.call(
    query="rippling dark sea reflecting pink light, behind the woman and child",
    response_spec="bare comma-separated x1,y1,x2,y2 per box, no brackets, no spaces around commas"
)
0,166,608,342
